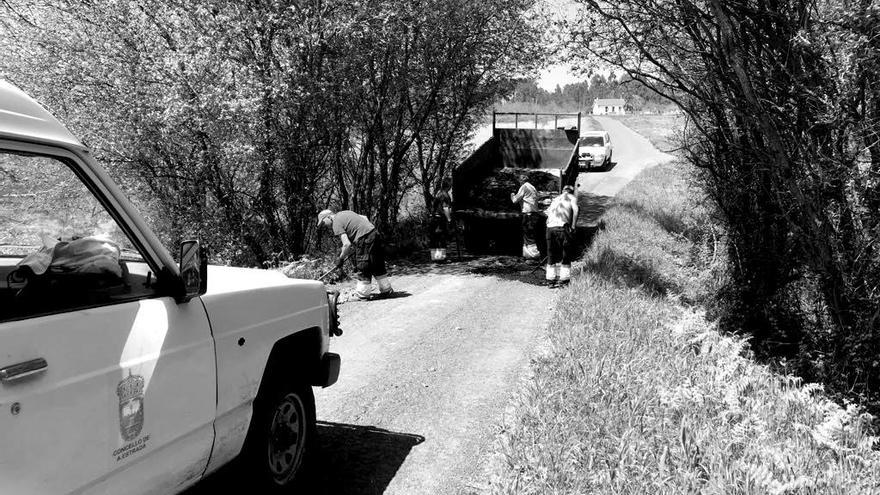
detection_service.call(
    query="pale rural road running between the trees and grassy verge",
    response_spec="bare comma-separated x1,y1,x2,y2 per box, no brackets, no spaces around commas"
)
190,119,664,495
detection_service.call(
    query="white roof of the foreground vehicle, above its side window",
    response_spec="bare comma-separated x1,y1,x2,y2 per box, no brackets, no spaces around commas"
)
0,79,84,148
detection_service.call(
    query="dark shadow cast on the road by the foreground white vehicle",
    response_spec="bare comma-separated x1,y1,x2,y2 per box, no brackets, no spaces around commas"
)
184,421,425,495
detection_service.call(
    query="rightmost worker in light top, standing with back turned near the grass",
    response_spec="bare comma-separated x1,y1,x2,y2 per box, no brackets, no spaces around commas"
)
546,186,578,287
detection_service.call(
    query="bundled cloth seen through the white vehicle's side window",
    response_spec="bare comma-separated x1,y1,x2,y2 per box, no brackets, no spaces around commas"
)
18,236,122,278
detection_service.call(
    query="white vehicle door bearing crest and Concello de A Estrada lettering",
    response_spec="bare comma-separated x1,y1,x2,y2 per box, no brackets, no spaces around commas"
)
0,148,216,495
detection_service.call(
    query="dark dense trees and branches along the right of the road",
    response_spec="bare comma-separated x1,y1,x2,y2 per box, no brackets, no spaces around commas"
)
570,0,880,407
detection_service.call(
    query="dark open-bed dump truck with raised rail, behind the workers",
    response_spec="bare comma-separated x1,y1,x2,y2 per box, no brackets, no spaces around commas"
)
452,112,581,255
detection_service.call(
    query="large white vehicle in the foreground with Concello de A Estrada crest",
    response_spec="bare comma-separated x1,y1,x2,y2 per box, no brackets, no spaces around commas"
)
0,81,340,495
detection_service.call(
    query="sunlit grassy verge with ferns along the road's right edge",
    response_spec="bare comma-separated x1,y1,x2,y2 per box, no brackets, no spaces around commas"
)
488,158,880,494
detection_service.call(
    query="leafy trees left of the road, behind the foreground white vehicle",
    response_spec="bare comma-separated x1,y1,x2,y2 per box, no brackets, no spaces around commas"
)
0,0,540,264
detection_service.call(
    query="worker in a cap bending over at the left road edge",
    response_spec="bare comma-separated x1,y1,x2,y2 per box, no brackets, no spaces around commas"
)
318,210,393,299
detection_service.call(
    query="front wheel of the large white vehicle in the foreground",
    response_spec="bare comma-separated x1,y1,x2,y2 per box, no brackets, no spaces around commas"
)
244,383,316,491
